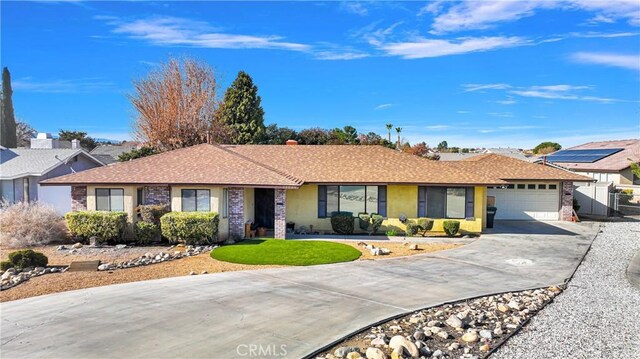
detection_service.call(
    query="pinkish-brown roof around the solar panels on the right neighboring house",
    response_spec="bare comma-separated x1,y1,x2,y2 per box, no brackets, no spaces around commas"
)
554,139,640,172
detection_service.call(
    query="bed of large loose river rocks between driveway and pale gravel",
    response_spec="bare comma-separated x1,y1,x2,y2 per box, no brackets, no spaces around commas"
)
317,287,562,359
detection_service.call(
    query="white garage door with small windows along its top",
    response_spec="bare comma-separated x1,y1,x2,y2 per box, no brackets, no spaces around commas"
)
487,183,560,221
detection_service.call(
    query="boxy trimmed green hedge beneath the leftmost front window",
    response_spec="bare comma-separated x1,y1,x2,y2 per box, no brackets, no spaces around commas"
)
64,211,127,243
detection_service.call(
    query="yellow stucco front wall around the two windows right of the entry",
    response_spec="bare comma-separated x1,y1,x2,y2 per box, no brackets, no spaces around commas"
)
286,185,487,233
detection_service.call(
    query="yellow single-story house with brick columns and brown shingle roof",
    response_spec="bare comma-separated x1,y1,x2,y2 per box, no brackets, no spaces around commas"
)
45,141,588,238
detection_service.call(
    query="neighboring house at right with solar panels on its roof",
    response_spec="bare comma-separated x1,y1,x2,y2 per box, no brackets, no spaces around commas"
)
538,139,640,216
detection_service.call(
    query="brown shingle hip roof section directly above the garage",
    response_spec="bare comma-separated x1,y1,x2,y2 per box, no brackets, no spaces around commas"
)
449,153,593,181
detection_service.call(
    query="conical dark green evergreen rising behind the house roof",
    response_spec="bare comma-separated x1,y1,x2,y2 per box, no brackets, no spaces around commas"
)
221,71,265,144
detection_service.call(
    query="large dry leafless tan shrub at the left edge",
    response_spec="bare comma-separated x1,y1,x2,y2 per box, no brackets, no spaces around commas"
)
0,202,67,248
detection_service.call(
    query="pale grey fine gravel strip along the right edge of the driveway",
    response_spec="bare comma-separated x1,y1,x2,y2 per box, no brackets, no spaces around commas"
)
491,222,640,359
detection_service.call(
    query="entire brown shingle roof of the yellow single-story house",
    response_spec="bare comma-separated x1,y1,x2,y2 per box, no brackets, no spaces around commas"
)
42,144,589,188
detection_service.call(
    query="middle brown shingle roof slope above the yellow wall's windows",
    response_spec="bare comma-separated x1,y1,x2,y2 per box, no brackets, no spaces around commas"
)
225,145,504,184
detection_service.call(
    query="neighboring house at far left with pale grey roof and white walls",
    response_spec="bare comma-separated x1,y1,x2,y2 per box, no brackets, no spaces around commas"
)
0,135,103,214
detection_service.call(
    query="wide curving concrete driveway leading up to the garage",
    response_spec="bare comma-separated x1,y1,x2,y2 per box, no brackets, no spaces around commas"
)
0,222,598,358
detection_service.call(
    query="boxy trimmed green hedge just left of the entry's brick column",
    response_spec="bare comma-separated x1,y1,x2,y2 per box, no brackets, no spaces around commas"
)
160,212,220,245
